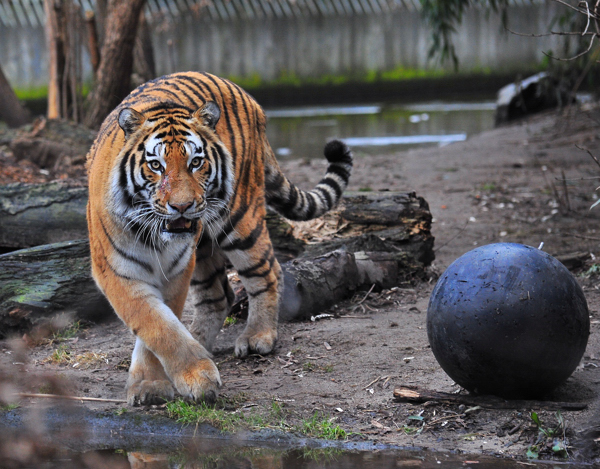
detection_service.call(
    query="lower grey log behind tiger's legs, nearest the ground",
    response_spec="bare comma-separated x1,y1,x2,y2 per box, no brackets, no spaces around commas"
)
0,240,418,337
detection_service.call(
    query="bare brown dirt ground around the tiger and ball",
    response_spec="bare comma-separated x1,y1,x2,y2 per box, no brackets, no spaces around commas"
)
0,108,600,461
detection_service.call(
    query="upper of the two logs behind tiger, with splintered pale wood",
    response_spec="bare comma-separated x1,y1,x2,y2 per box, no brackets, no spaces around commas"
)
0,182,435,271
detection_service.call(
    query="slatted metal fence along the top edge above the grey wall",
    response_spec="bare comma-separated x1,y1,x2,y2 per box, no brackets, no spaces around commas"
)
0,0,548,27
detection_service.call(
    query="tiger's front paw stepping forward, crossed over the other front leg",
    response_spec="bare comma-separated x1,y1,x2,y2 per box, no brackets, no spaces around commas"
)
172,358,221,402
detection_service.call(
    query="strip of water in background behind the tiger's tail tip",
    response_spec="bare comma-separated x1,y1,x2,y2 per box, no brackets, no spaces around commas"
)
266,101,495,159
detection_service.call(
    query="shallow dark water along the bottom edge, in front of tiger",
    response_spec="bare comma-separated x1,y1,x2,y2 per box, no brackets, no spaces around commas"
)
0,406,590,469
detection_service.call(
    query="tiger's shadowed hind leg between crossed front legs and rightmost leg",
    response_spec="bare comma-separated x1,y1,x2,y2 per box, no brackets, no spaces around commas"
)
190,238,235,352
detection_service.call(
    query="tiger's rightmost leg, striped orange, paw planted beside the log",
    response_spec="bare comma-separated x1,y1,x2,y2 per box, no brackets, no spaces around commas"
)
223,218,283,357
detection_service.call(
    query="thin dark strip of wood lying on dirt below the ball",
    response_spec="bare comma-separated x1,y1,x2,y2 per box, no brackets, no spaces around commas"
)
394,386,587,410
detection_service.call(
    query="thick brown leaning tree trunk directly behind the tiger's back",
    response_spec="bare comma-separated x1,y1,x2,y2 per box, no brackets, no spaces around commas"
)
85,0,145,128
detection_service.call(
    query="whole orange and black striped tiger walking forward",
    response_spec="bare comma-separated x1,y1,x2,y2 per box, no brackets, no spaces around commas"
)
88,72,352,404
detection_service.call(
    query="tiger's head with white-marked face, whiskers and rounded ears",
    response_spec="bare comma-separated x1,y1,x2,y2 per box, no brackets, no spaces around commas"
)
113,101,233,243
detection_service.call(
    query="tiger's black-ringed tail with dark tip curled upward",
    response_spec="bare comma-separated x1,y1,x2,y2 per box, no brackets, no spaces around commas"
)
265,140,352,221
